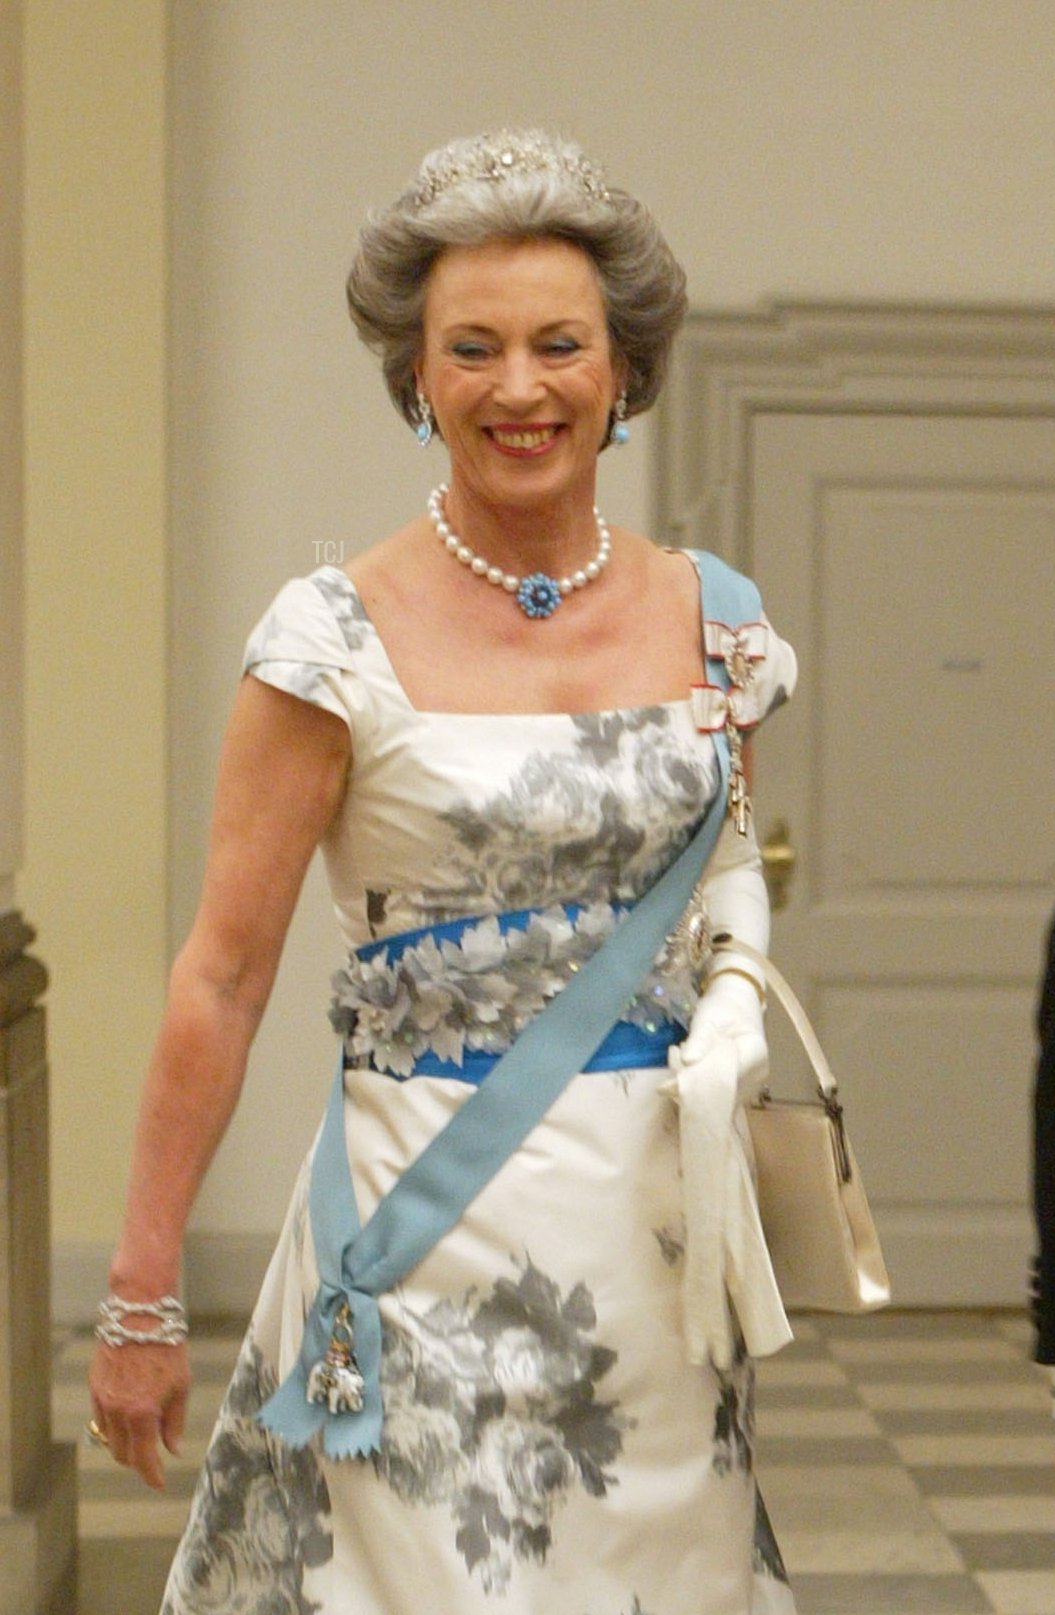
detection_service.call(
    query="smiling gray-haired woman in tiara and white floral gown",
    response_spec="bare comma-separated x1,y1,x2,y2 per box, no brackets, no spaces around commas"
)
92,131,795,1615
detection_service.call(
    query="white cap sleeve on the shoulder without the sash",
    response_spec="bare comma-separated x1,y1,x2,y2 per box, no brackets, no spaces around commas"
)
242,573,364,732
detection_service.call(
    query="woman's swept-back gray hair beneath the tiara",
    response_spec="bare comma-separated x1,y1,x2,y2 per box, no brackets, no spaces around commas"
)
347,129,687,426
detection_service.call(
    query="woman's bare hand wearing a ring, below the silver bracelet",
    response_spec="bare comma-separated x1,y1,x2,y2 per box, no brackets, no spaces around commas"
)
89,1319,191,1492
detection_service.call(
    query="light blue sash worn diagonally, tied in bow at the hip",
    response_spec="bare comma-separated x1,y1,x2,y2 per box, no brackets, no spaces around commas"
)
258,552,761,1458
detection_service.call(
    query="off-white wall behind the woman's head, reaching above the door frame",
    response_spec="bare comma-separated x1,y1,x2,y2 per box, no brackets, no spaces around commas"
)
171,0,1055,1272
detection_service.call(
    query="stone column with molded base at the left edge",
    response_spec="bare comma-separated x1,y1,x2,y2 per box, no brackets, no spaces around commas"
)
0,0,76,1615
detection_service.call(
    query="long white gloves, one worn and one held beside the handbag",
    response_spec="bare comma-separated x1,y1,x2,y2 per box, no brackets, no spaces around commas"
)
666,820,792,1370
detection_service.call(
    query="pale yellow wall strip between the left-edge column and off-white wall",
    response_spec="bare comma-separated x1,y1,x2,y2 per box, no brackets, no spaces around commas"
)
22,0,168,1292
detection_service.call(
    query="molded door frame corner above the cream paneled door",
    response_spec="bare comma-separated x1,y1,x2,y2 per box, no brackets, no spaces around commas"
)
653,302,1055,572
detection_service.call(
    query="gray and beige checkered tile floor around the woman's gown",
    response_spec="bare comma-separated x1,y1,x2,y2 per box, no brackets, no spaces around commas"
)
45,1313,1055,1615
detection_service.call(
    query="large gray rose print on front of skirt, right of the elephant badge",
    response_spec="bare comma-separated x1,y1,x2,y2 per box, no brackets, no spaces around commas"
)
375,1261,627,1592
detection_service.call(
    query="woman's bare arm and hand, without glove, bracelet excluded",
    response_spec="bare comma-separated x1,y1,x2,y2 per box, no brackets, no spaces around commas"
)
92,677,351,1486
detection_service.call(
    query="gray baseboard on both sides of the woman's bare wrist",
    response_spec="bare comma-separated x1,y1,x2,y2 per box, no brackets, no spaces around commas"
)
52,1232,275,1329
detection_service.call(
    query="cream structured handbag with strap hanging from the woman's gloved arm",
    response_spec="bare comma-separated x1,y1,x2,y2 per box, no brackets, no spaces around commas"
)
714,938,890,1313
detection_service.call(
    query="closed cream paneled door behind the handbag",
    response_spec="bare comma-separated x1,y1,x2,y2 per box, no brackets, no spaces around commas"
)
742,407,1055,1305
